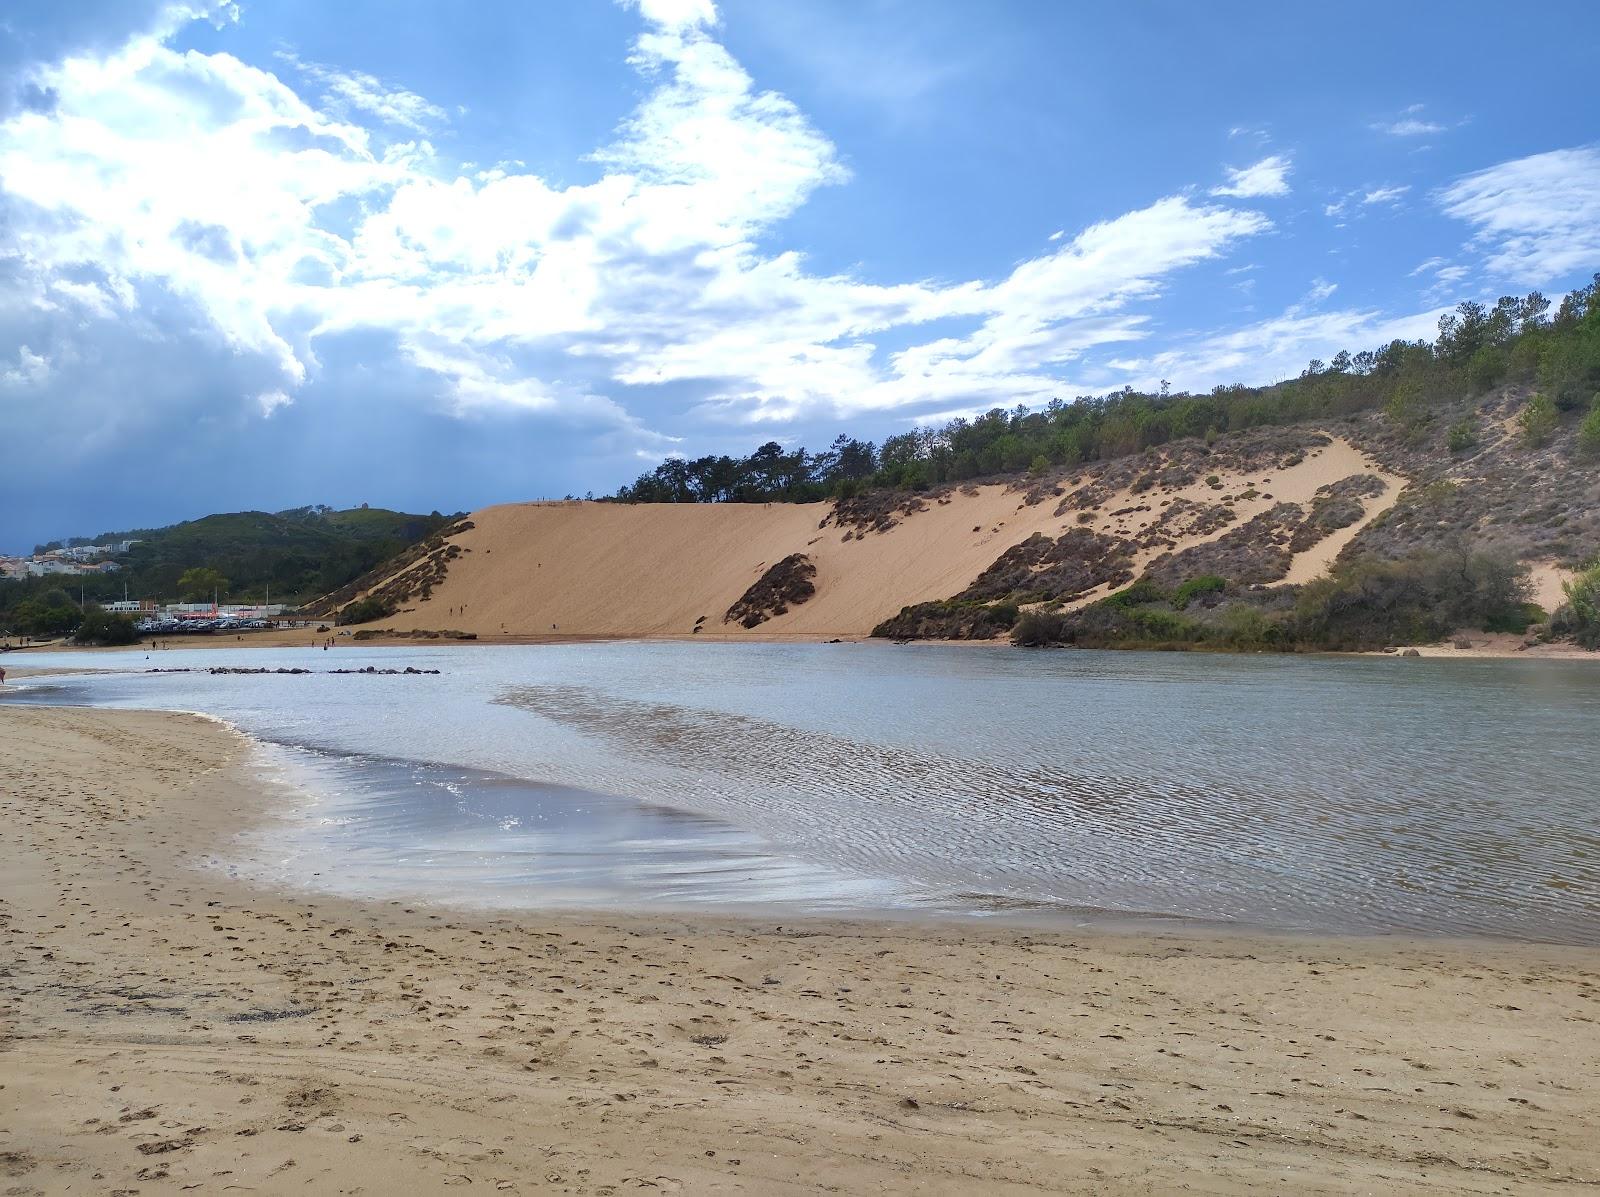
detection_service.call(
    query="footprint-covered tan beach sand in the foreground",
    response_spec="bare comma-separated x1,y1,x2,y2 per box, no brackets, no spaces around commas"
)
0,704,1600,1194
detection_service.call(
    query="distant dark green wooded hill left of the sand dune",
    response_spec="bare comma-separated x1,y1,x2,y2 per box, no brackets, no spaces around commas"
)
9,506,464,608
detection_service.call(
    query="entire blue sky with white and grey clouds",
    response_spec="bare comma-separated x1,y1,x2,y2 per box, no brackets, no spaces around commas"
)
0,0,1600,552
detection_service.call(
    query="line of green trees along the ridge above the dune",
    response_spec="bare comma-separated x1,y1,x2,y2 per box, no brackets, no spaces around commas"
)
608,274,1600,502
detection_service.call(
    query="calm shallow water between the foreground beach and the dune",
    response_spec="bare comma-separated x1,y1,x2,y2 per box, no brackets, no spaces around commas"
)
8,643,1600,944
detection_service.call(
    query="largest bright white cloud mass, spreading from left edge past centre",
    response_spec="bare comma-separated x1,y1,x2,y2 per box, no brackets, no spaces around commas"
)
0,0,1288,464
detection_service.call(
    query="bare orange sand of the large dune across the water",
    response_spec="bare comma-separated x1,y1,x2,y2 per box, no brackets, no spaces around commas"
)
371,440,1403,639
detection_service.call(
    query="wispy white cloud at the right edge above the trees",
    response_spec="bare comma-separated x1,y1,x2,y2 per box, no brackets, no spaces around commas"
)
1438,146,1600,283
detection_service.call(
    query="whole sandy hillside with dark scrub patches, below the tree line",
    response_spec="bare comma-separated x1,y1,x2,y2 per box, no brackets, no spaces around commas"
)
318,389,1600,656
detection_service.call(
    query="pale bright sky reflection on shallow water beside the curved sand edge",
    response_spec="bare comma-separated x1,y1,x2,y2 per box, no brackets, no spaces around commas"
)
230,749,908,911
